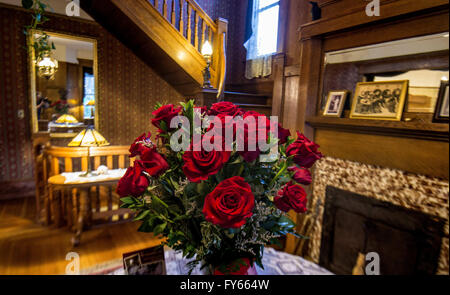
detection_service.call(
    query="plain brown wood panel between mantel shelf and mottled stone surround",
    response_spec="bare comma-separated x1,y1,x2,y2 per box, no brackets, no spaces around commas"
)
315,129,449,179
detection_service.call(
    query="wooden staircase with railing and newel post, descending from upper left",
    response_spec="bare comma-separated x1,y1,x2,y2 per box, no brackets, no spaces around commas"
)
80,0,228,96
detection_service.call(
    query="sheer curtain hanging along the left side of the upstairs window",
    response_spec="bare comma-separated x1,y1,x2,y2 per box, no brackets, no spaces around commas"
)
244,0,272,79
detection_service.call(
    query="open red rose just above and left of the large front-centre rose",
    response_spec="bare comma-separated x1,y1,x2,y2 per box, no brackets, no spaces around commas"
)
183,136,231,183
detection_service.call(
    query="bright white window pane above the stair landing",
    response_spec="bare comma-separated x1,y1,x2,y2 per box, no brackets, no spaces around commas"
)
246,0,280,60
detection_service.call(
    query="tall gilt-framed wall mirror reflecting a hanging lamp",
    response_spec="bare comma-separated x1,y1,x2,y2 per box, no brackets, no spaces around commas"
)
28,32,98,137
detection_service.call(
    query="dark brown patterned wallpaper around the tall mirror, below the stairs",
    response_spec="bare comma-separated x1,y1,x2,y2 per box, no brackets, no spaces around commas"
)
0,7,183,182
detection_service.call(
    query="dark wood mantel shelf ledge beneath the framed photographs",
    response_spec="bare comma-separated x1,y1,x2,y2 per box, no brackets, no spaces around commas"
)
306,116,449,142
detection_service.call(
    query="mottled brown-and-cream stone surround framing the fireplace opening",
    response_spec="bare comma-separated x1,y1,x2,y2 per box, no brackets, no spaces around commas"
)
307,157,449,275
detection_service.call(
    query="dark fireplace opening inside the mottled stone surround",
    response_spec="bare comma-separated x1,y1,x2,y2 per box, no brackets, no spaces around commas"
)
320,186,445,275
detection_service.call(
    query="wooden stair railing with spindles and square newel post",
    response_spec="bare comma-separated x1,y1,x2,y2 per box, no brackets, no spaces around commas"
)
148,0,228,97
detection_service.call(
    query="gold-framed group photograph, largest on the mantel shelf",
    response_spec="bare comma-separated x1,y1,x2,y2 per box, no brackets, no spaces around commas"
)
350,80,409,121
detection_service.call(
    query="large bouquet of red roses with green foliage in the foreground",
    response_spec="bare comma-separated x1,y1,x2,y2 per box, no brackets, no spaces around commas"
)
117,101,322,274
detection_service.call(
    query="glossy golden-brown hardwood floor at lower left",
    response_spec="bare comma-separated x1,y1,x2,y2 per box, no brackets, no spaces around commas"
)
0,198,160,275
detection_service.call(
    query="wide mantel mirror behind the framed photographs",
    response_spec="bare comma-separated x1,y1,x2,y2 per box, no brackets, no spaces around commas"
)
322,33,449,113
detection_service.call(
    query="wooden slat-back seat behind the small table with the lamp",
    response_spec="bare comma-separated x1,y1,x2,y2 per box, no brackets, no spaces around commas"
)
37,146,134,228
